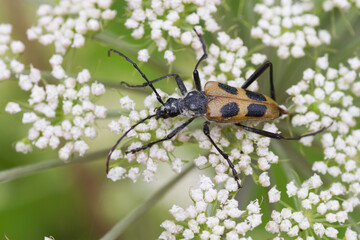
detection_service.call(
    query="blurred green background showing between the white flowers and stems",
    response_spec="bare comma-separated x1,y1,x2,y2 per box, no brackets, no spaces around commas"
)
0,0,359,239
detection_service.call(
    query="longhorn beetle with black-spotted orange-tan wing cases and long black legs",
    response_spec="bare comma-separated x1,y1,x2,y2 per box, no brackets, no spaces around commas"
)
106,28,328,188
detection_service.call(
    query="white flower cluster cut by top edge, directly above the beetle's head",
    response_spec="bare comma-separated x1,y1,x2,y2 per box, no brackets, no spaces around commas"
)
125,0,222,64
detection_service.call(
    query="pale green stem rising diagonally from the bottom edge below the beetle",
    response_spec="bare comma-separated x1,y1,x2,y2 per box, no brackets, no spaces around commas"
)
101,164,194,240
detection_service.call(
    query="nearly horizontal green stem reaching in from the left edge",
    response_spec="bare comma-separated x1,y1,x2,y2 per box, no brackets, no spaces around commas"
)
0,149,109,182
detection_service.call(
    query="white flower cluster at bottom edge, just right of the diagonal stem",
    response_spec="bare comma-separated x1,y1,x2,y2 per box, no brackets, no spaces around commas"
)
159,176,262,240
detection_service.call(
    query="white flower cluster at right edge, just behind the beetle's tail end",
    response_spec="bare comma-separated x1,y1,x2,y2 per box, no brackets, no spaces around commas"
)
287,55,360,134
